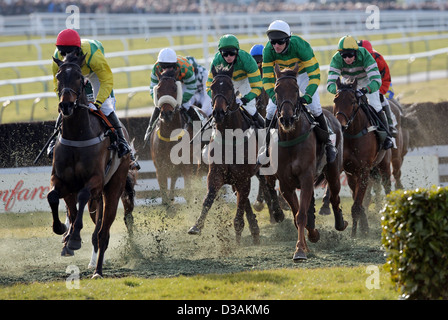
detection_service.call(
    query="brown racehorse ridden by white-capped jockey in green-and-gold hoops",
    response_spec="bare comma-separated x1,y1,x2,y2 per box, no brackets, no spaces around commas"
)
270,64,347,262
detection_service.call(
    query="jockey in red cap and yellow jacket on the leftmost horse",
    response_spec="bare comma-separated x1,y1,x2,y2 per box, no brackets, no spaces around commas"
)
47,29,133,160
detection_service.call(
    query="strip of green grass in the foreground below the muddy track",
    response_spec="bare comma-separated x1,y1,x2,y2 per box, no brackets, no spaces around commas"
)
0,266,398,300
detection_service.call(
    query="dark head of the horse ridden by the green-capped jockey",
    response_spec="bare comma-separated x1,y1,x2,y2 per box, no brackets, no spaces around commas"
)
210,65,238,123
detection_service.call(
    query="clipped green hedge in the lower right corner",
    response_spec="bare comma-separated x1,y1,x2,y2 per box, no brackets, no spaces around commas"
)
382,187,448,299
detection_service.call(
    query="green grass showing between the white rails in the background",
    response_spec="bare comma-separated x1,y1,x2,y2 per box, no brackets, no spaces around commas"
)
0,33,448,123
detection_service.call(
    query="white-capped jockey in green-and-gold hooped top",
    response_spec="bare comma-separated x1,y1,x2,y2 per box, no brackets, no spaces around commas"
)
263,20,338,163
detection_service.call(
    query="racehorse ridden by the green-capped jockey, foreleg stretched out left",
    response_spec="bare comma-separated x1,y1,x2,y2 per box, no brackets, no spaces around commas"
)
188,66,283,244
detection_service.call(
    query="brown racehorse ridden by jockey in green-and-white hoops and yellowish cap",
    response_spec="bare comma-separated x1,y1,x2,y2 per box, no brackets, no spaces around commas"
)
330,79,391,237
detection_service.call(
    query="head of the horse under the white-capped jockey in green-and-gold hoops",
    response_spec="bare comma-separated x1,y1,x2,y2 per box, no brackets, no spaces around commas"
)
274,63,299,131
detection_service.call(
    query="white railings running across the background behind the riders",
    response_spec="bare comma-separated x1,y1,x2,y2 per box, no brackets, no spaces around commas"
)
0,11,448,123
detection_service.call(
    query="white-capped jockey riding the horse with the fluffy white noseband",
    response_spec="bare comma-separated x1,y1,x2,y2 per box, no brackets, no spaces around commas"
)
145,48,200,141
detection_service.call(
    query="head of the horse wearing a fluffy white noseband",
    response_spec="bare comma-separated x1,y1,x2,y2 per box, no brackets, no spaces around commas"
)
154,69,182,121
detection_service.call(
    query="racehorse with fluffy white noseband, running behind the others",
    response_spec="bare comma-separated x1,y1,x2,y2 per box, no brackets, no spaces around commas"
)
150,70,195,205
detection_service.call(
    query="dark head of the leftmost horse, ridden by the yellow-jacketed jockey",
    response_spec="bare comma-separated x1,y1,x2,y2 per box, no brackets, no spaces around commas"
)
53,53,87,116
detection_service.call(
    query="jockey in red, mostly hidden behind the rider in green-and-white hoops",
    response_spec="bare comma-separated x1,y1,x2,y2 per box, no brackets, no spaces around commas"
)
358,40,397,136
